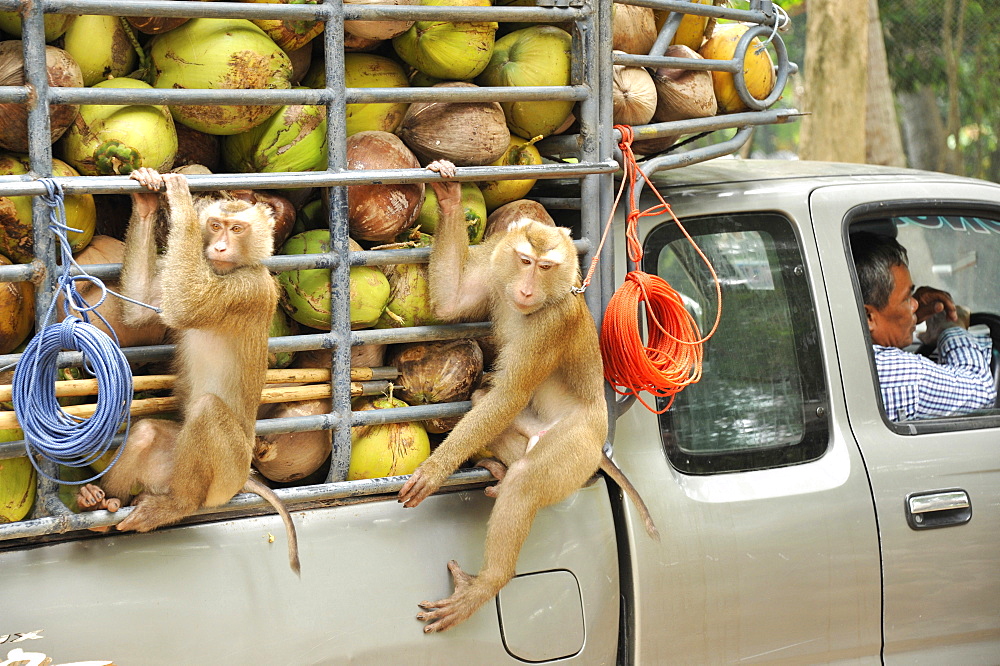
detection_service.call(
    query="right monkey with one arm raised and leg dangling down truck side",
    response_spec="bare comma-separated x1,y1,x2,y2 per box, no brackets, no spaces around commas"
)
399,161,659,633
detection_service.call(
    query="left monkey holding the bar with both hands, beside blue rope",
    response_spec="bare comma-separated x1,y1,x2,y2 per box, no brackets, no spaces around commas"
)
77,168,299,573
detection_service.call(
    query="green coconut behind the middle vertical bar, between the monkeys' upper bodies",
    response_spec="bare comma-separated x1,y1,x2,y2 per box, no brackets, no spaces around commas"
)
278,229,389,331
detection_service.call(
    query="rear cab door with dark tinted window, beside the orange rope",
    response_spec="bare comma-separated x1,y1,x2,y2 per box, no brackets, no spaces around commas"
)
615,205,880,664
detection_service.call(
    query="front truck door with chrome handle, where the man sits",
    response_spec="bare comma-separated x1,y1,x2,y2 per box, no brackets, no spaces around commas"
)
812,177,1000,664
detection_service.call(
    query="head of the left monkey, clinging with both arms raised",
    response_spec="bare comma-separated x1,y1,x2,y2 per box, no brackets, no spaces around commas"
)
199,199,274,274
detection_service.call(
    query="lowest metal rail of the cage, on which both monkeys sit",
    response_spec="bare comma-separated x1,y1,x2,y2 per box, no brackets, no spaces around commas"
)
0,462,493,541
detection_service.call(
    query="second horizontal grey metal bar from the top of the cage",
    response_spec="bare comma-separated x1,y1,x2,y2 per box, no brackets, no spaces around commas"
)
21,85,584,106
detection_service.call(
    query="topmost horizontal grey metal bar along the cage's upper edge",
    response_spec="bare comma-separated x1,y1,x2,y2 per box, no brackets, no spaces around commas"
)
0,0,588,23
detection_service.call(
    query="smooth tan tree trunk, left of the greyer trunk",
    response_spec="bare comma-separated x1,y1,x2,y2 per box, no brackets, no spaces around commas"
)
799,0,868,162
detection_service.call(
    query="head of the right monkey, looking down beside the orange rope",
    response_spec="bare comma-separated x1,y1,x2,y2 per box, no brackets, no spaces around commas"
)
491,219,580,315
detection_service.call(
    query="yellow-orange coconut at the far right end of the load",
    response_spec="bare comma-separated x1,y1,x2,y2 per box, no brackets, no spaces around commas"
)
699,23,775,113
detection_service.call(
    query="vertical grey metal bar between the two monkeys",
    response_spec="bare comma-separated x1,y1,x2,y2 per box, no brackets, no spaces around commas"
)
323,0,351,482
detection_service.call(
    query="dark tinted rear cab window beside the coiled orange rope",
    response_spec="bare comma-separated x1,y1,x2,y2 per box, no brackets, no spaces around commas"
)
644,213,827,474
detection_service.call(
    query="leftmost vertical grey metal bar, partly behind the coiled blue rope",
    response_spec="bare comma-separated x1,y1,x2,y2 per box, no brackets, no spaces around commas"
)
21,2,72,517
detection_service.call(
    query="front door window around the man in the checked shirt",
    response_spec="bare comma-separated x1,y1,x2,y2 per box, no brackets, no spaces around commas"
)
850,209,1000,426
